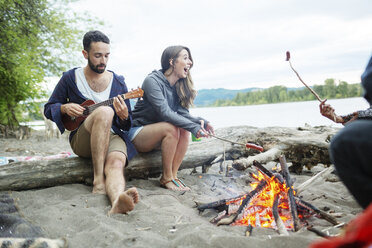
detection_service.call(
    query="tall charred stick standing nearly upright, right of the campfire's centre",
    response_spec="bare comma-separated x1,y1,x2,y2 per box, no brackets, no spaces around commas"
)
279,155,300,232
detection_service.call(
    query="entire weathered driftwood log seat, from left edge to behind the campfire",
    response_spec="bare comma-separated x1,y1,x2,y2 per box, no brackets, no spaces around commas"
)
0,126,337,191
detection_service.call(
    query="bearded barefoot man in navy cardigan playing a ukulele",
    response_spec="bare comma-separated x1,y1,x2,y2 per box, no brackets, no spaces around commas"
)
44,31,138,215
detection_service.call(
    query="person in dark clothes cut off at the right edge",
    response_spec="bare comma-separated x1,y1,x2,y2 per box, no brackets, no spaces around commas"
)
320,57,372,208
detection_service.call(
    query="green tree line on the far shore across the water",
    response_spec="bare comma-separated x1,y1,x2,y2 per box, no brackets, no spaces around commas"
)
210,79,363,107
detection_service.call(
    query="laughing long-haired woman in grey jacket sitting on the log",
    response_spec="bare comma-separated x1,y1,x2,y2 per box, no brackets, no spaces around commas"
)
129,46,214,191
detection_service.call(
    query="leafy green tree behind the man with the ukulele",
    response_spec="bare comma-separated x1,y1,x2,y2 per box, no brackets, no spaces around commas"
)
0,0,102,127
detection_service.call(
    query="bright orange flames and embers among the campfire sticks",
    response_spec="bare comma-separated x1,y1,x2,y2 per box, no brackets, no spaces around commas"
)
226,171,293,228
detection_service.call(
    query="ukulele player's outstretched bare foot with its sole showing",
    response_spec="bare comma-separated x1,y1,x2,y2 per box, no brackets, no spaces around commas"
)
108,187,139,216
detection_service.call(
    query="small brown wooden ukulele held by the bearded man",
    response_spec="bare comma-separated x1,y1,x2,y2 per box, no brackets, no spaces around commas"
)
62,88,143,131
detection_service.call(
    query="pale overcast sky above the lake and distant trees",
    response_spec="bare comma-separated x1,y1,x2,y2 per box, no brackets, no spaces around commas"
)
71,0,372,89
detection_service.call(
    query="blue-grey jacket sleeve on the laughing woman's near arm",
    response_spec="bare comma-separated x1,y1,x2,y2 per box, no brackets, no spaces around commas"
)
142,77,200,135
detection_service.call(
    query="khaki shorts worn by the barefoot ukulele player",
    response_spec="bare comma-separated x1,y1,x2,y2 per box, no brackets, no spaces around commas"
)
70,124,128,158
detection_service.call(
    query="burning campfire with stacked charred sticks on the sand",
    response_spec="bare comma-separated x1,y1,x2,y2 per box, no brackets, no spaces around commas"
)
198,155,339,236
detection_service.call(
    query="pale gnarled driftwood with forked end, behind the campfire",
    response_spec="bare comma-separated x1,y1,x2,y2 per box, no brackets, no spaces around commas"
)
232,126,339,173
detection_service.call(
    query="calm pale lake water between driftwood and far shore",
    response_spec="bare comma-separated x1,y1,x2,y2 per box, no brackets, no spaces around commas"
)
190,97,369,129
